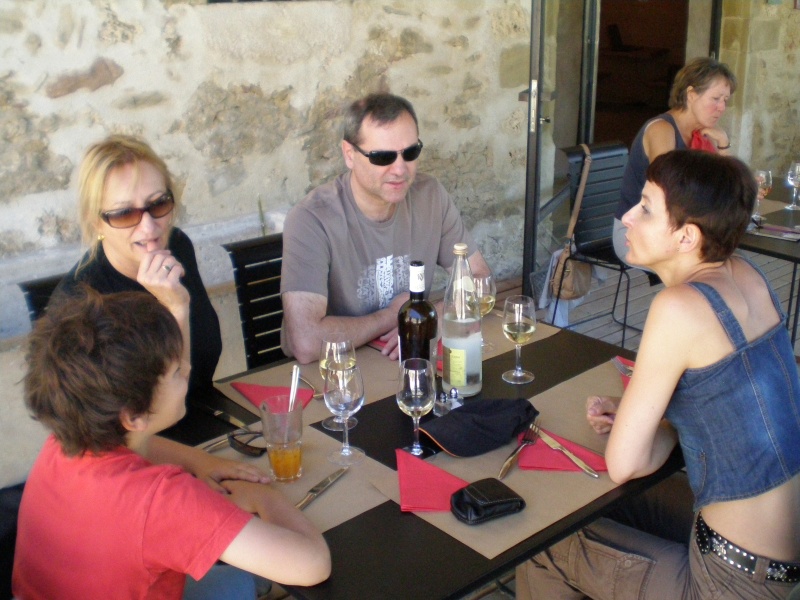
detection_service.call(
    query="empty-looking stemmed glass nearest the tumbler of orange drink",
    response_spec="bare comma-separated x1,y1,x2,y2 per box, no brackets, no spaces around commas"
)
323,363,364,466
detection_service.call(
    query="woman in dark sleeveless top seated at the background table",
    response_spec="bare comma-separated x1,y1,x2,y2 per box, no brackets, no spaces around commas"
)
614,58,736,262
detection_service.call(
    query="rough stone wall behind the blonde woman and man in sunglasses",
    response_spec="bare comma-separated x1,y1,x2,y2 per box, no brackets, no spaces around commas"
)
0,0,530,338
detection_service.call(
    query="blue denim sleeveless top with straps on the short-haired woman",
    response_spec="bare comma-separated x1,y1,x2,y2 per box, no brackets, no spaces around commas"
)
666,274,800,510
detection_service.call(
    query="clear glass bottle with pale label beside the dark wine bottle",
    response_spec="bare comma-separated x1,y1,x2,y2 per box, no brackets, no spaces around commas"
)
442,243,483,396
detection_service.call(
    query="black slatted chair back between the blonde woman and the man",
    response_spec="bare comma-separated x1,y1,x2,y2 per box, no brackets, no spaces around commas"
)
222,233,286,369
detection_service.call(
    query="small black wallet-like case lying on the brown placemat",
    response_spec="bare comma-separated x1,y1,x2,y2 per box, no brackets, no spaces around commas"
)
450,477,525,525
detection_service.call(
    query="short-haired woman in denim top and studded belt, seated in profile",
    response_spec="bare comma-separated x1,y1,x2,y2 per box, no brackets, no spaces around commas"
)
517,150,800,600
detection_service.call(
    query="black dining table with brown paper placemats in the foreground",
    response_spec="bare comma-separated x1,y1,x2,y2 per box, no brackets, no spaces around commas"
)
201,309,683,600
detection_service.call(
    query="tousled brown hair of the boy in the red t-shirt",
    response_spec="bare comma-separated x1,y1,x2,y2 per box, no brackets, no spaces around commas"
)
25,286,183,456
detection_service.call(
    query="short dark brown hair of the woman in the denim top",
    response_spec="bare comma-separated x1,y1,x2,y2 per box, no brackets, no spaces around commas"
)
647,150,758,262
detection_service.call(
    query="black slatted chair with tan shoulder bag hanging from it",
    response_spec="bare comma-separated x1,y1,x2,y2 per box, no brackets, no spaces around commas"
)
553,142,640,346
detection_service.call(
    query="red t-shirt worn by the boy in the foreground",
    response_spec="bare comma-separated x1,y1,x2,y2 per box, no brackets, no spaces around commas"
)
13,436,253,600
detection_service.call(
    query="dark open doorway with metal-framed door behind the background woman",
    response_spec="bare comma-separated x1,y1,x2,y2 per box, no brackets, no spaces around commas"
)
522,0,722,295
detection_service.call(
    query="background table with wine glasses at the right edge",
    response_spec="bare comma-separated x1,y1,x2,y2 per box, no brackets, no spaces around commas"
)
739,184,800,345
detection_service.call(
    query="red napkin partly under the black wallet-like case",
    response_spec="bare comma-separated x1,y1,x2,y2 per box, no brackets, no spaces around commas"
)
395,450,469,512
